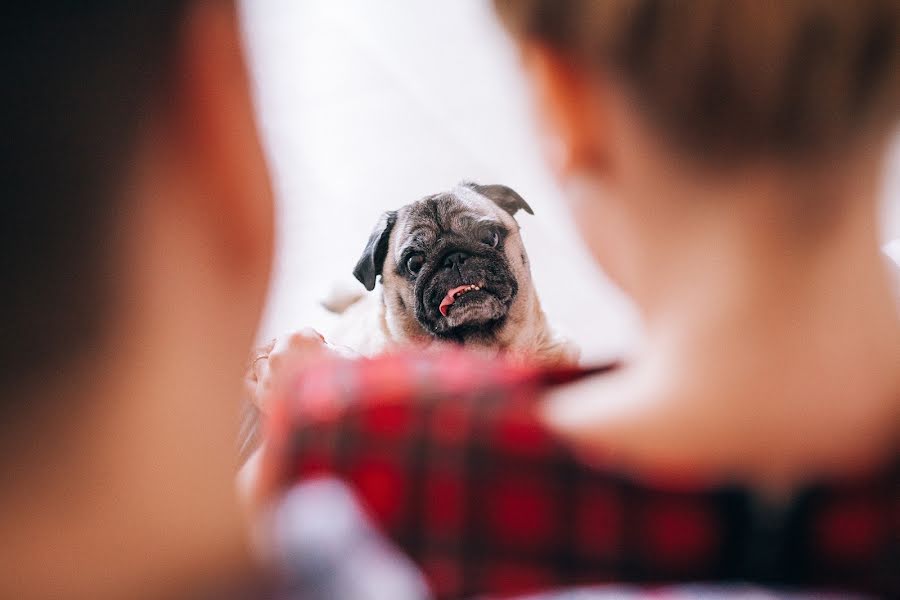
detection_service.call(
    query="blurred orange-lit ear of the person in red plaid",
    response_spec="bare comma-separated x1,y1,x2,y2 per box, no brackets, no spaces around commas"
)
520,41,609,178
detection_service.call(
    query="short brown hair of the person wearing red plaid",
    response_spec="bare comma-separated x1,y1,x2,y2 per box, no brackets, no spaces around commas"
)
494,0,900,159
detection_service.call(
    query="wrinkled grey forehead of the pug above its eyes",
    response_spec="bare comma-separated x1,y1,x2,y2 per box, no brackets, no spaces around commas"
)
397,187,515,244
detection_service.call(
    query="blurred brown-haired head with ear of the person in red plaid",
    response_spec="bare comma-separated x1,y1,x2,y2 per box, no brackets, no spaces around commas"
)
495,0,900,298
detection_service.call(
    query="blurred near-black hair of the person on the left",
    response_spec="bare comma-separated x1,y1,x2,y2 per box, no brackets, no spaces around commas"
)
0,0,189,414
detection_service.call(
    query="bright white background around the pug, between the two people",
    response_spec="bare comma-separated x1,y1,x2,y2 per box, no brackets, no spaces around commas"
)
243,0,900,360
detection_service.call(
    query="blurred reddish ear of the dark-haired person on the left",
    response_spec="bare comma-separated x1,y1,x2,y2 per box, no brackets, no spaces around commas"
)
172,2,274,278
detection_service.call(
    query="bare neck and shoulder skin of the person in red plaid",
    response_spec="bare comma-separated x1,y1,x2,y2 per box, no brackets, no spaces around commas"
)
543,154,900,492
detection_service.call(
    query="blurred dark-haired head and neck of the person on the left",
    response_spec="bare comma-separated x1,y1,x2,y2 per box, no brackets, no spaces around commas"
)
0,0,273,598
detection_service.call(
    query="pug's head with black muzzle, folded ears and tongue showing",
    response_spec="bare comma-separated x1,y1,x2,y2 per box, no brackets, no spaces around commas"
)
354,183,533,344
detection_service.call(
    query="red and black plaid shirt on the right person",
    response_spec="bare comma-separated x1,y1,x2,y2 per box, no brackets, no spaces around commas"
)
270,352,900,598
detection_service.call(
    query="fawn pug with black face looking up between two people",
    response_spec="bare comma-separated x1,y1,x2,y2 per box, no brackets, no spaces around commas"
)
326,182,578,364
